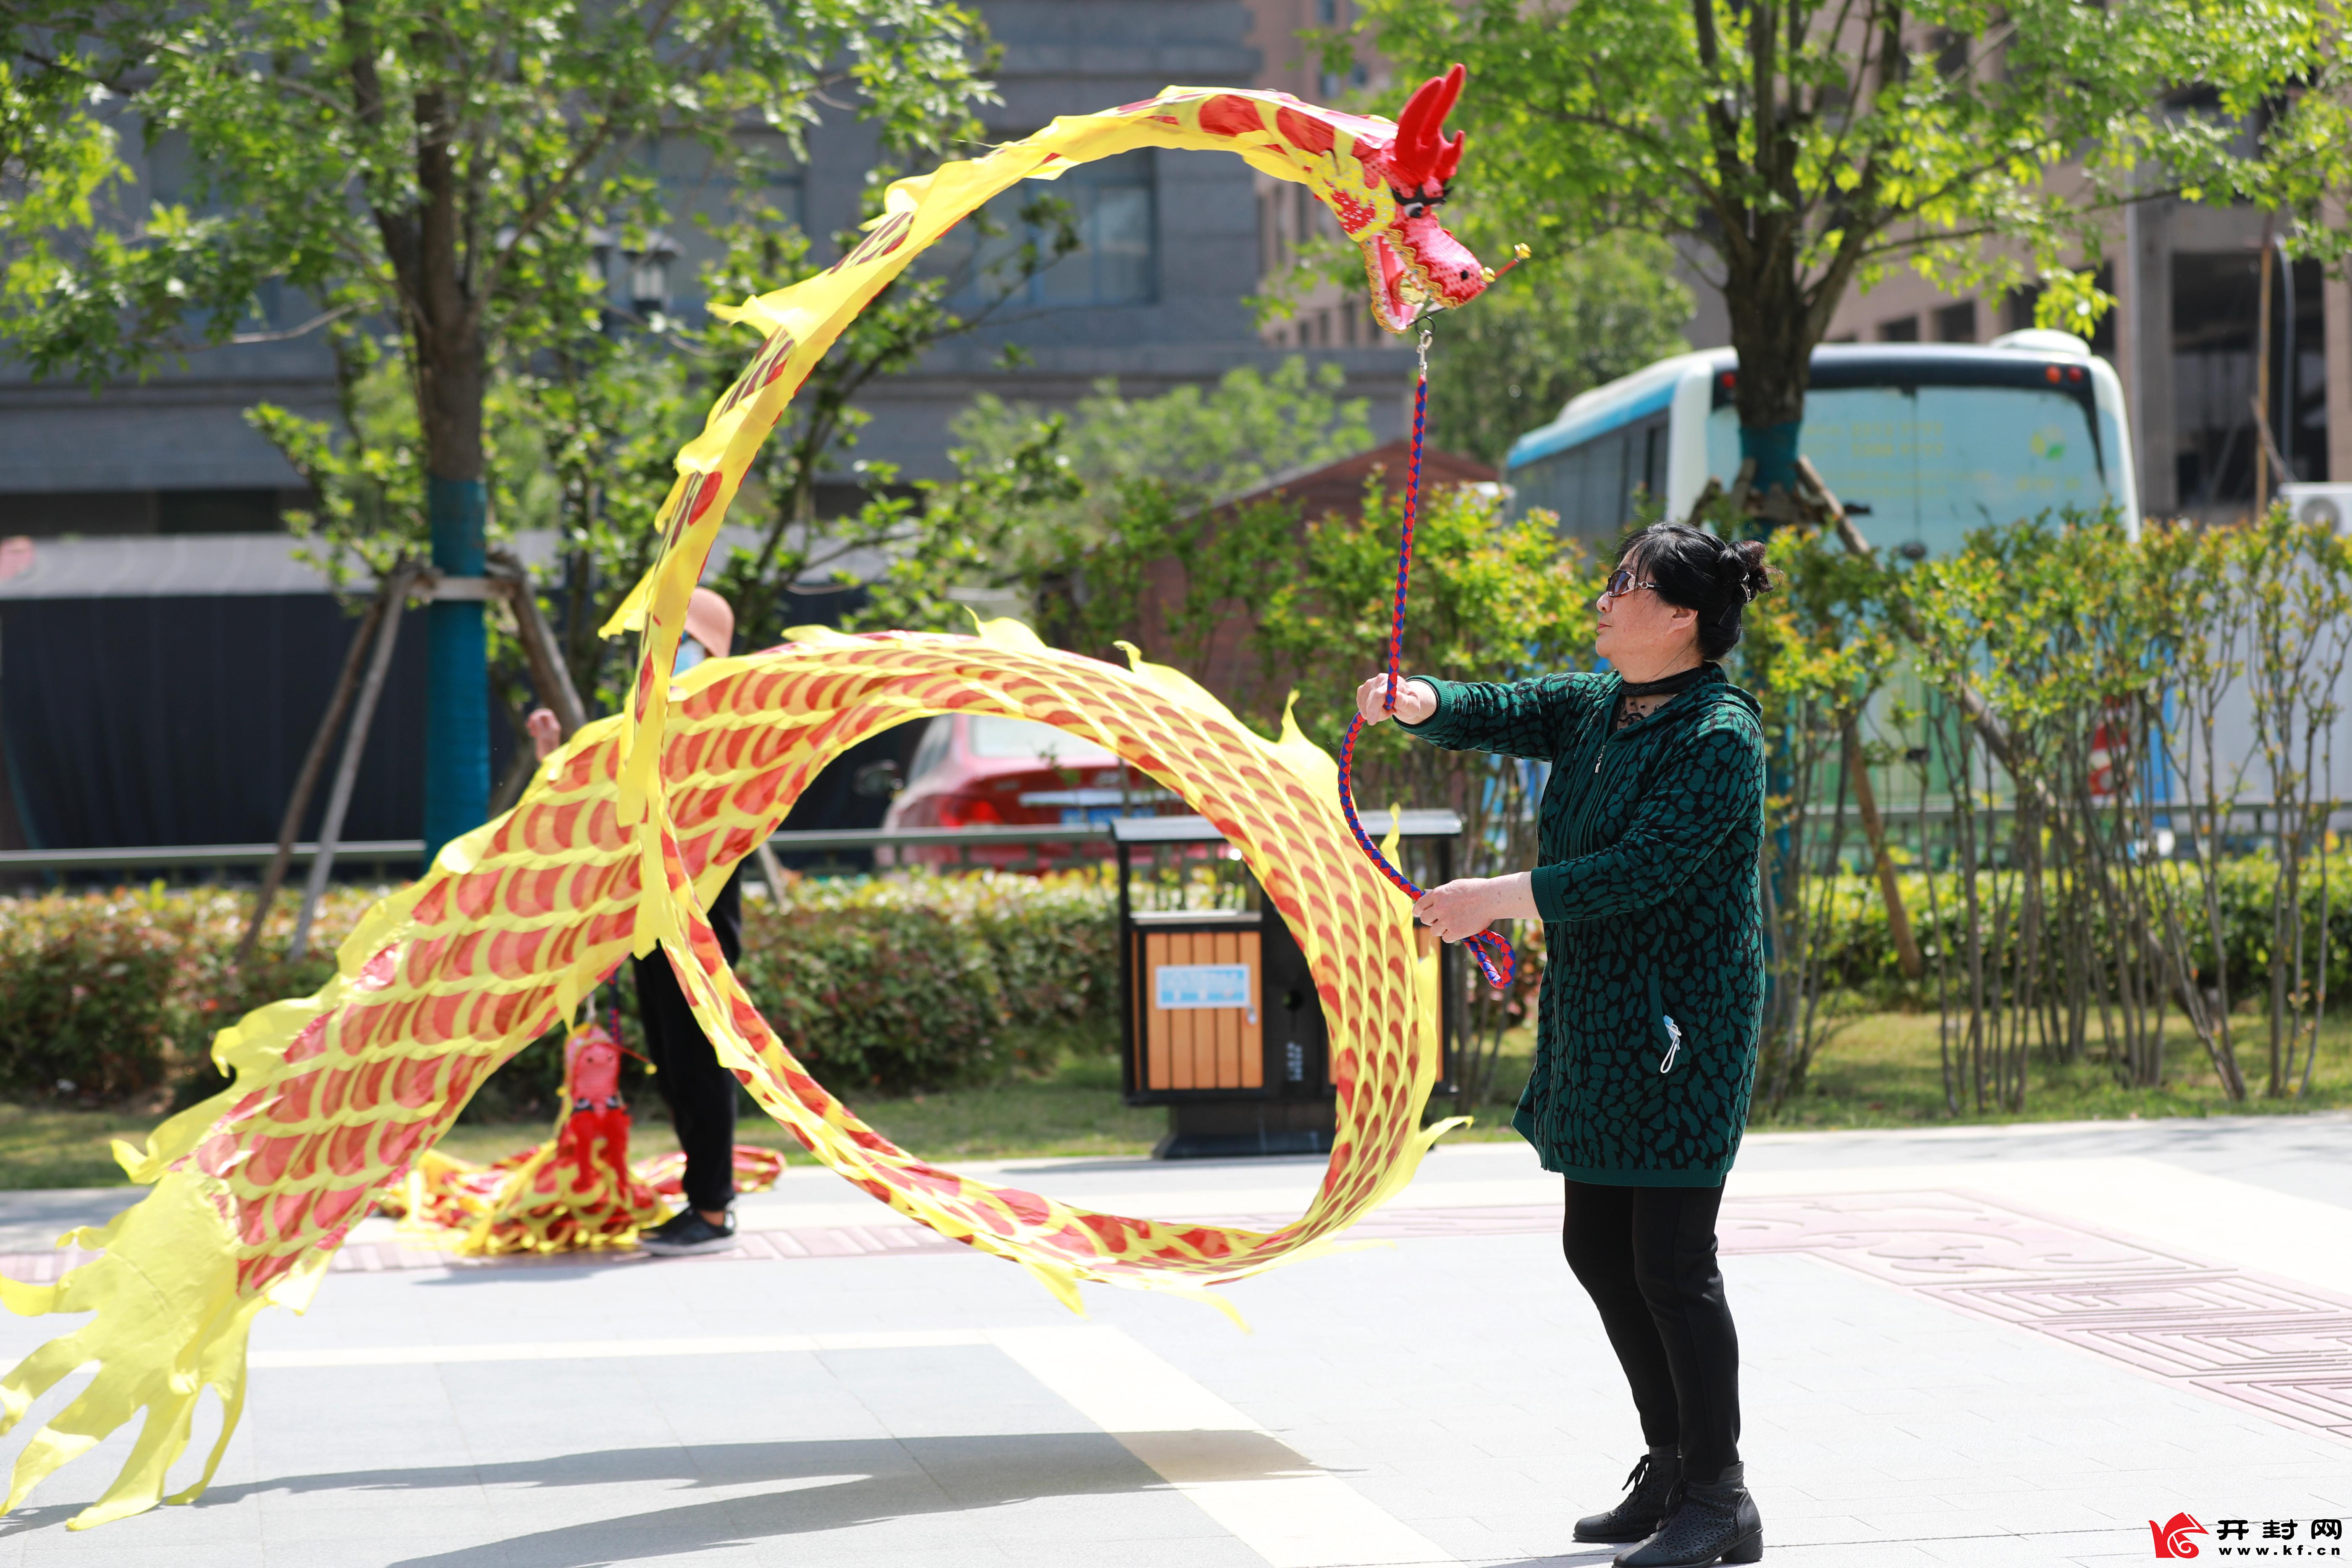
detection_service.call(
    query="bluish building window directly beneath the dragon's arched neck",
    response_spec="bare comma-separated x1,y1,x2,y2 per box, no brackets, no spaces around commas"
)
931,148,1159,308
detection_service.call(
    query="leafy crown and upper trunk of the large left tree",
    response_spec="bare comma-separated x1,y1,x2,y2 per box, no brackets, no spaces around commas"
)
5,0,988,501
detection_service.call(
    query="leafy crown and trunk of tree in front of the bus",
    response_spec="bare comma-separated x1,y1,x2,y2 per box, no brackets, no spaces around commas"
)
1359,0,2352,503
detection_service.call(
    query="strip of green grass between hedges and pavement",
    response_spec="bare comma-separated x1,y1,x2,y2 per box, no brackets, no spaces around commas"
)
18,1013,2352,1190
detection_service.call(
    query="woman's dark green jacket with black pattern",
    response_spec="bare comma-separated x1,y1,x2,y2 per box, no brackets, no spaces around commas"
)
1406,665,1764,1187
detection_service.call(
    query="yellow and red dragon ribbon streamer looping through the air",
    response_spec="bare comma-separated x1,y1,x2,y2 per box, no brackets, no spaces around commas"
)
0,75,1484,1528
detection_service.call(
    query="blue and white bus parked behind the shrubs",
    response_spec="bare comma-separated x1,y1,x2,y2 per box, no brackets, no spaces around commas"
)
1505,331,2140,555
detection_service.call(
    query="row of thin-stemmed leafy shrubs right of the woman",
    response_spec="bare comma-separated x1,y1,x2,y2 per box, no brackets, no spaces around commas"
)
1806,508,2352,1112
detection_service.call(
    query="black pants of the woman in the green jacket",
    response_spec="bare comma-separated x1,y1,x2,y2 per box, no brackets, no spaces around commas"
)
1559,1180,1741,1481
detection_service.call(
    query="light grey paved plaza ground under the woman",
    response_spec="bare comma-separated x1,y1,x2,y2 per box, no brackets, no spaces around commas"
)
0,1114,2352,1568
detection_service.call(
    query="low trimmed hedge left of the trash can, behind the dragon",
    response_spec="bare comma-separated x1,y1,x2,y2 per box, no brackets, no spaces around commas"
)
0,872,1120,1119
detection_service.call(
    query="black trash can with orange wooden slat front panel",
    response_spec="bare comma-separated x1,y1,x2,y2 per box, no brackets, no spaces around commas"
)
1112,811,1460,1159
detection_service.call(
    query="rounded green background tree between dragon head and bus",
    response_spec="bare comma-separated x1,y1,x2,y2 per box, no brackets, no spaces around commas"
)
1430,235,1691,465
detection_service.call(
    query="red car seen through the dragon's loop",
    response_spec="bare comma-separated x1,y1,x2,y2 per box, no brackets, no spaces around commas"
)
875,712,1171,865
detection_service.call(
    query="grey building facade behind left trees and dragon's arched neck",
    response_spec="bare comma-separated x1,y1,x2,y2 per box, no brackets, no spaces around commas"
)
0,0,1406,538
